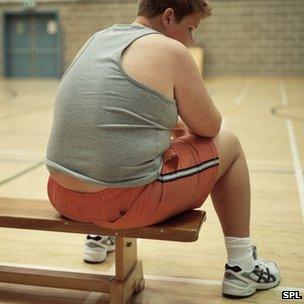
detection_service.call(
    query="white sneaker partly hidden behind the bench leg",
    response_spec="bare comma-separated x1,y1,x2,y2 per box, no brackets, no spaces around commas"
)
83,234,115,263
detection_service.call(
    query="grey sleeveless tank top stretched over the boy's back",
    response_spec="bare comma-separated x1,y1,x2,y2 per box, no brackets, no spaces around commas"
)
45,24,178,187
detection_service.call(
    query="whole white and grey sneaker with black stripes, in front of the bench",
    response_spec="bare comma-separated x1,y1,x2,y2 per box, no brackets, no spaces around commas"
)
222,246,281,298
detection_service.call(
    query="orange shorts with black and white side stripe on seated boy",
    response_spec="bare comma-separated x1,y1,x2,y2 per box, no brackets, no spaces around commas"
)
48,135,219,229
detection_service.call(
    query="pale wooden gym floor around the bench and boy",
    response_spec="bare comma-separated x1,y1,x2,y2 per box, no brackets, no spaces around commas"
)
0,78,304,304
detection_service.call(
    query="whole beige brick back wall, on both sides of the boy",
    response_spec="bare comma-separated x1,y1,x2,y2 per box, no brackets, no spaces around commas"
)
0,0,304,76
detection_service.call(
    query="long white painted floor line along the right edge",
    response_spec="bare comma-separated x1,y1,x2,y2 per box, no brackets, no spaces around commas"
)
279,83,304,220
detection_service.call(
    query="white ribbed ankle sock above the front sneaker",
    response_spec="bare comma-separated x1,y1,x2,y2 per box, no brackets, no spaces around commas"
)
225,236,256,272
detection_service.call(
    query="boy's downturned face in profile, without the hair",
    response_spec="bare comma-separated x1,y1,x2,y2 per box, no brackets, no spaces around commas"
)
164,13,202,47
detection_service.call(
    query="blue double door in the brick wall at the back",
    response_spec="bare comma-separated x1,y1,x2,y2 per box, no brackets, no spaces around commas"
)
6,14,60,77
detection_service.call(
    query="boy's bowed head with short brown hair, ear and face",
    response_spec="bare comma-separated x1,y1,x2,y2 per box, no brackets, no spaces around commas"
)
138,0,211,46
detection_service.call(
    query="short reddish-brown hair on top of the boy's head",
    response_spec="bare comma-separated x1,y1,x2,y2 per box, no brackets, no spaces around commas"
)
138,0,212,22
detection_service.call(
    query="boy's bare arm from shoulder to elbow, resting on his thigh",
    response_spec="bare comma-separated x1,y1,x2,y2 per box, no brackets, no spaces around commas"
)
170,43,222,137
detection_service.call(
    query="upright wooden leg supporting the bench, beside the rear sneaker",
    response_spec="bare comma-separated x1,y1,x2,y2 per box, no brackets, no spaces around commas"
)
110,237,144,304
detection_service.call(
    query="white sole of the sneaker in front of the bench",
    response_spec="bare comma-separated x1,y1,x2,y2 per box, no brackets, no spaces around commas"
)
222,281,280,299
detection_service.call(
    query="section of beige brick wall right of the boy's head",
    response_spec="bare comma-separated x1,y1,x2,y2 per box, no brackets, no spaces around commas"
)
196,0,304,76
